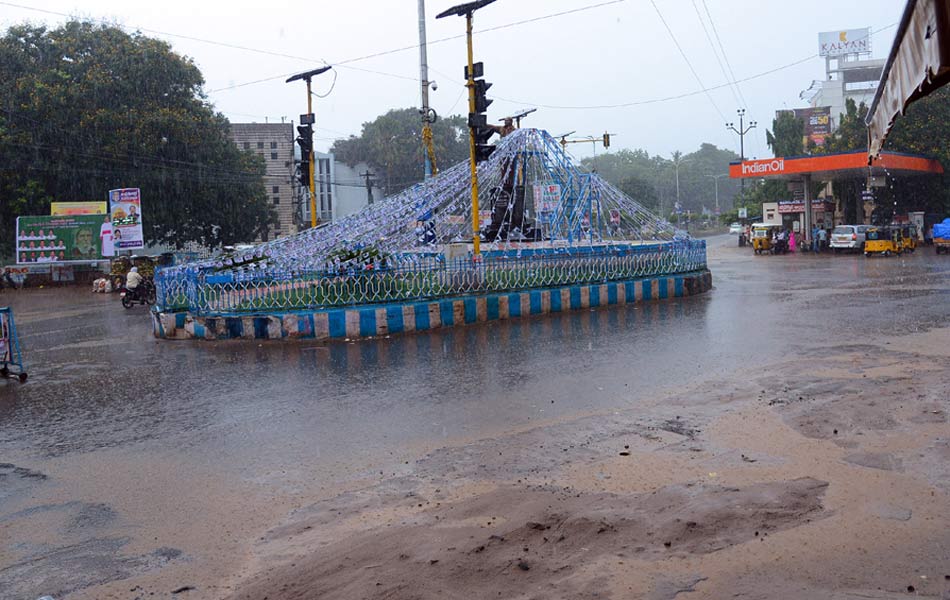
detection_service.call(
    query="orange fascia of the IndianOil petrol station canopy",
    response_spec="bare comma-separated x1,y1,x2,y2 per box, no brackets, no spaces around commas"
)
729,150,950,181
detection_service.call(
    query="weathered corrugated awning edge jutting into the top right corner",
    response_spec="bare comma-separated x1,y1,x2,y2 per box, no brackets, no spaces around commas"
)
865,0,950,163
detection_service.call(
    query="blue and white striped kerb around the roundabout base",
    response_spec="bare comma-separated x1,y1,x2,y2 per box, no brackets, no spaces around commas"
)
152,271,712,340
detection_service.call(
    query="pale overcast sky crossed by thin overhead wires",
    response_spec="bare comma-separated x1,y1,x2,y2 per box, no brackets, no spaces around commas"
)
0,0,904,162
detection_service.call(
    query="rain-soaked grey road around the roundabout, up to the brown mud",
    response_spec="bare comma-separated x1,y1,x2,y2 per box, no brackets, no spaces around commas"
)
0,236,950,597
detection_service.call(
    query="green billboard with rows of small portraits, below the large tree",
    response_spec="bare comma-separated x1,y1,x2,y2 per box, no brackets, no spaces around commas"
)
16,215,109,265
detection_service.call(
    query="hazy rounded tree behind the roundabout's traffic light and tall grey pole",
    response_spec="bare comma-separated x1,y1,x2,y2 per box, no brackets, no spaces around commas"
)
330,108,469,195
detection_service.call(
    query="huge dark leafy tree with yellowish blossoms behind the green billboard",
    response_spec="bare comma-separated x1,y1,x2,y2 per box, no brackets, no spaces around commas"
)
0,21,275,252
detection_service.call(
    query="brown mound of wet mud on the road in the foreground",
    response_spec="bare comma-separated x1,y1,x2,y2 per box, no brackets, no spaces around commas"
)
234,478,827,600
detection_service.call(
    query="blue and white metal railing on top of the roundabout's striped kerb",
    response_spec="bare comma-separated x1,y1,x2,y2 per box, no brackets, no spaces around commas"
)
155,240,706,315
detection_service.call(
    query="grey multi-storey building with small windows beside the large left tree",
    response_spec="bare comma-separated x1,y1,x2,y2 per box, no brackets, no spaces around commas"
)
231,123,297,239
